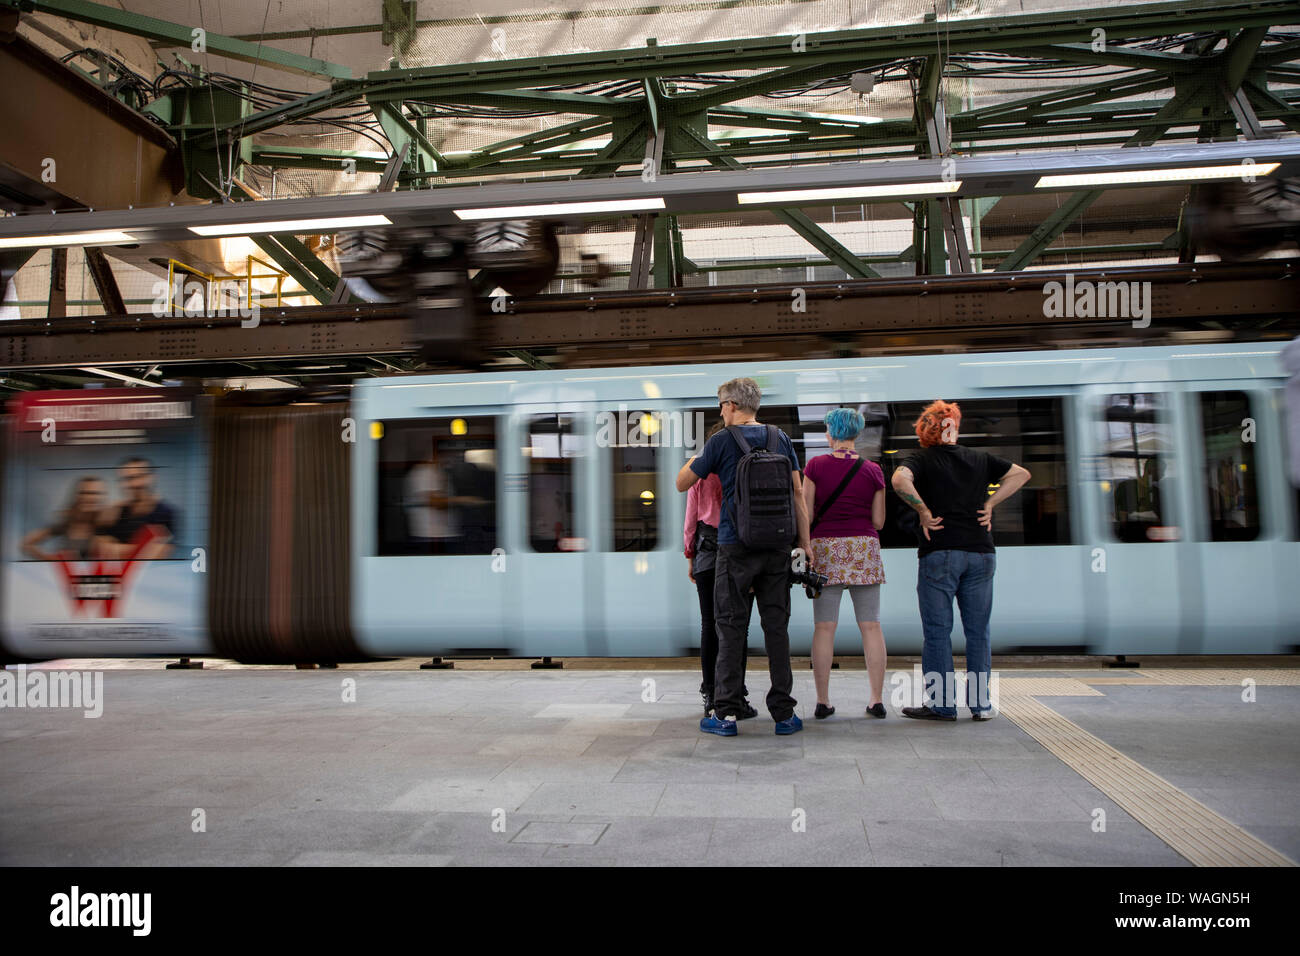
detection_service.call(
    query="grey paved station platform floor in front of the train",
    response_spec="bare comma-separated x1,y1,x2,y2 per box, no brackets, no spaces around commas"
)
0,658,1300,868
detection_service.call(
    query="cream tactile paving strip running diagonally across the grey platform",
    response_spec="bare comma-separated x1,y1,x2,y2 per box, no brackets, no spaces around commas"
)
998,680,1296,866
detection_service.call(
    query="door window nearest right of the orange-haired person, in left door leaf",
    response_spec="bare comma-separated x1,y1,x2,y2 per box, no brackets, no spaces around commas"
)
1095,393,1180,542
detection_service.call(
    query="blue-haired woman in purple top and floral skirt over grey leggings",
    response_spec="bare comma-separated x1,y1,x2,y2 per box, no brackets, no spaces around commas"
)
803,408,885,719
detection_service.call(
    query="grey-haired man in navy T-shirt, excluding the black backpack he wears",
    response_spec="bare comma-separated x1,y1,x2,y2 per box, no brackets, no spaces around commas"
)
677,378,813,736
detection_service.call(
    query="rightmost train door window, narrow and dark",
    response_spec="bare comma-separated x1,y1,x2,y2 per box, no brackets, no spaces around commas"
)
1200,392,1260,541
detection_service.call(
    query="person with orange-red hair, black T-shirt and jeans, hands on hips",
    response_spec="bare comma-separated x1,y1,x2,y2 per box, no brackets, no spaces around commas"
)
891,399,1030,721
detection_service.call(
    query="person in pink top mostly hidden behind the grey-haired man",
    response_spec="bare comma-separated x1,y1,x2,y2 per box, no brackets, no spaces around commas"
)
681,421,758,721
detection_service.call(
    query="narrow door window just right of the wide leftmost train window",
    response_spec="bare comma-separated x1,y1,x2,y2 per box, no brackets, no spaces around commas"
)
523,414,586,551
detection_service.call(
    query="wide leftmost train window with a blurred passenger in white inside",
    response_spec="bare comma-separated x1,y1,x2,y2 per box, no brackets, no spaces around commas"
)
376,415,497,555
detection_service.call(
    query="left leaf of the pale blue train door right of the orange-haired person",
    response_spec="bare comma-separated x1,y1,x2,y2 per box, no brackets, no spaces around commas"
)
1080,385,1203,654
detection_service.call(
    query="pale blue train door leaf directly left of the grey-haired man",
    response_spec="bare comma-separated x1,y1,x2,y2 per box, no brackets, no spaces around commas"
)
593,401,686,657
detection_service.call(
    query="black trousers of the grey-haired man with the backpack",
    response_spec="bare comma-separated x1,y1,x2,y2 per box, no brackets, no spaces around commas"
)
714,545,797,721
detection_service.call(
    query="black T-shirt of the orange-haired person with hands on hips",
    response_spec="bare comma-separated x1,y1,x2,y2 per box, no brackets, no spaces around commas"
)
898,445,1011,555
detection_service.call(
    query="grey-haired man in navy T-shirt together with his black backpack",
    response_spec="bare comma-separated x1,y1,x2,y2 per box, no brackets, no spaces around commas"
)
677,378,813,737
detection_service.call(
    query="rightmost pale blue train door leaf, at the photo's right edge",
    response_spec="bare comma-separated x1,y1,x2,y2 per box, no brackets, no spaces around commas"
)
1186,389,1300,654
